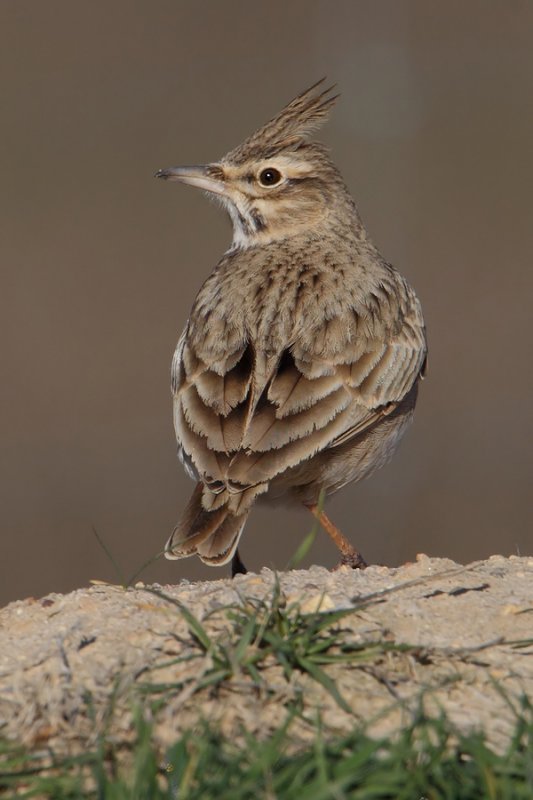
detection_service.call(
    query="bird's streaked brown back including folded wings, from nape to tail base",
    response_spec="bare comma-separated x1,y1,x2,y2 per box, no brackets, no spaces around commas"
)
173,228,425,507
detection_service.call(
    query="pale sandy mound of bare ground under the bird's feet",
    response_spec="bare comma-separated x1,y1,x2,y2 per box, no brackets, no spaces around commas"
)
0,555,533,752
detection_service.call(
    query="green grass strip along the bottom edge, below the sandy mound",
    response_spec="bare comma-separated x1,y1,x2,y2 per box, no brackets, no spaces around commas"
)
0,699,533,800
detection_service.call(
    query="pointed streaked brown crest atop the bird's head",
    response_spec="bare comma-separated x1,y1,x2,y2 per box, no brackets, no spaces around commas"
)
224,78,339,164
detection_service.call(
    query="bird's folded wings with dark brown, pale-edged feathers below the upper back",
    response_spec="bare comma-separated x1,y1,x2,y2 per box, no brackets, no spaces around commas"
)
173,282,426,493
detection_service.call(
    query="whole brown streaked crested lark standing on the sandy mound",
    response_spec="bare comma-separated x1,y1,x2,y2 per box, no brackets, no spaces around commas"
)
155,78,427,575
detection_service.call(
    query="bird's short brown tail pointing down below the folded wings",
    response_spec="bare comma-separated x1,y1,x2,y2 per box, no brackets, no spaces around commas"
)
165,482,249,567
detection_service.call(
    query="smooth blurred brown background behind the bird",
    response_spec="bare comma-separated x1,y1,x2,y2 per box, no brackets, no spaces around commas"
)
0,0,533,603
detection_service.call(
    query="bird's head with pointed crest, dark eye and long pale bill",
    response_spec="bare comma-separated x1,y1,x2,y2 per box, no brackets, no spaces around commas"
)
156,81,356,248
